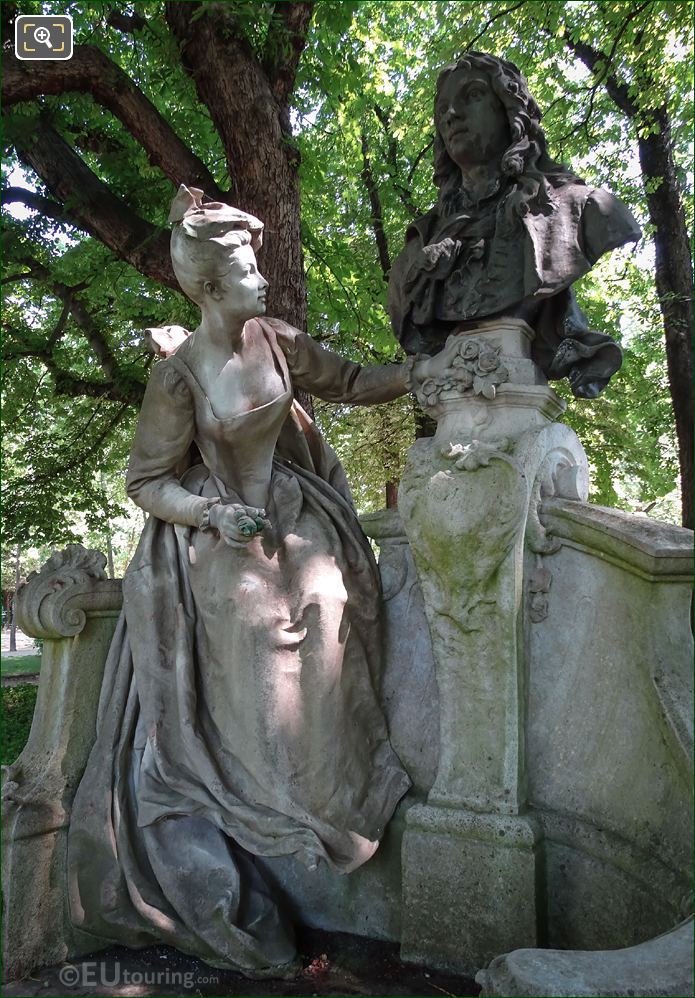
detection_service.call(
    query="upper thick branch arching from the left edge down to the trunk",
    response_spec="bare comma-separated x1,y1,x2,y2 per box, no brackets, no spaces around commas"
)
2,45,223,197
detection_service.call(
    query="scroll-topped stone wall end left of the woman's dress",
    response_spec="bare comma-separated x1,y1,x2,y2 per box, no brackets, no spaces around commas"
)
2,544,122,979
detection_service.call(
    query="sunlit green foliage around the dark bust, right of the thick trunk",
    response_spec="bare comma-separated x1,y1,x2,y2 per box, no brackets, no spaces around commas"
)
295,0,692,522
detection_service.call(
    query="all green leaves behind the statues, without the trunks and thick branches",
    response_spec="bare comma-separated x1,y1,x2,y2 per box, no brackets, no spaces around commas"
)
2,0,693,551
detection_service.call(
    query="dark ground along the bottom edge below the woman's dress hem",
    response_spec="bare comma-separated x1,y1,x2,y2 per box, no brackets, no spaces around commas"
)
3,929,480,998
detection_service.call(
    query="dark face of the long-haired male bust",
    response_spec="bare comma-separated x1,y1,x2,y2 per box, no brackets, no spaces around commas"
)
434,68,511,169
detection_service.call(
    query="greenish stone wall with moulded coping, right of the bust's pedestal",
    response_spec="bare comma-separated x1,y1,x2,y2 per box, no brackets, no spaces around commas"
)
527,499,693,949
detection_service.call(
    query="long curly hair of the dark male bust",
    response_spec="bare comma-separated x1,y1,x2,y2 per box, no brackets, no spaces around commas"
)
434,52,582,221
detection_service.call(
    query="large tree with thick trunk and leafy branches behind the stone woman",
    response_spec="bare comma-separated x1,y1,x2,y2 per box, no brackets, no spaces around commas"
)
2,3,322,540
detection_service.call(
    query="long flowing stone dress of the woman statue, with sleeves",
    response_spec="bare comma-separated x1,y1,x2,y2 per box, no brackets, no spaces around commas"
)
69,320,409,974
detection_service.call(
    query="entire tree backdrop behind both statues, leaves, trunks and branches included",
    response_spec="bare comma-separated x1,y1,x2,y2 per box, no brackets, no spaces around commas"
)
2,0,693,564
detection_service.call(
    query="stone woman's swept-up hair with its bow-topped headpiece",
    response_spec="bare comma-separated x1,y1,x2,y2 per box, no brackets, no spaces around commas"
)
169,184,263,305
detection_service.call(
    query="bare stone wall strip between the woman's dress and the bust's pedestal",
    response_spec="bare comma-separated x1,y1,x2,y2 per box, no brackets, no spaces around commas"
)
247,509,439,940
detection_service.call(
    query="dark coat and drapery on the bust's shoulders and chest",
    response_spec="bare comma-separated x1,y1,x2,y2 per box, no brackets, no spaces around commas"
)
389,179,641,394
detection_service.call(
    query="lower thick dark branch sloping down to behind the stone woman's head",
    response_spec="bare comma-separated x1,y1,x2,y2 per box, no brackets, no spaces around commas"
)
12,119,178,289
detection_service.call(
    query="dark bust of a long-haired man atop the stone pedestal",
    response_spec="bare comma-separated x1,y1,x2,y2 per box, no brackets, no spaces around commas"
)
389,52,641,398
